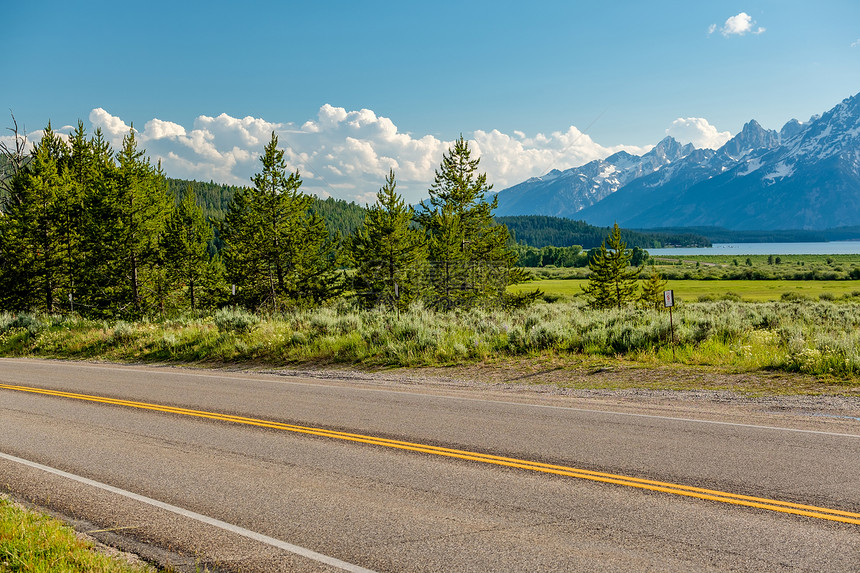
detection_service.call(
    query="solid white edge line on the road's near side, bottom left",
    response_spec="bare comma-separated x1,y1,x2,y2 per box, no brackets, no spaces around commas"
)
0,452,374,573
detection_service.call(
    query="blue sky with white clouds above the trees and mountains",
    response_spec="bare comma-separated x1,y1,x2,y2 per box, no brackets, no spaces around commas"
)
6,0,860,202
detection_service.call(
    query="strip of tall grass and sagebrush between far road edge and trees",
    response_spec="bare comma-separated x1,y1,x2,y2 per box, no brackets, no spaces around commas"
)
5,300,860,378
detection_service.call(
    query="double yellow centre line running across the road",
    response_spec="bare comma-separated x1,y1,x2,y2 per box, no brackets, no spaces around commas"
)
6,384,860,525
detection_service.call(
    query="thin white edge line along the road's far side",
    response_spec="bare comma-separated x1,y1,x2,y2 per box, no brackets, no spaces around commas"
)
5,358,860,438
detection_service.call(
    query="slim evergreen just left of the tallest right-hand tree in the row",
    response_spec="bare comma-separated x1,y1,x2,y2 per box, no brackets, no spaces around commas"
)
349,170,427,310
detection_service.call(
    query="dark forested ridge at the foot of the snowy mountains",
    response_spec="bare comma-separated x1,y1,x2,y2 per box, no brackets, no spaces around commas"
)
496,215,711,250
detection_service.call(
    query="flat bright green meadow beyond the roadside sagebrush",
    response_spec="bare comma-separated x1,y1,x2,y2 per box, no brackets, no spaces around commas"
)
511,279,860,302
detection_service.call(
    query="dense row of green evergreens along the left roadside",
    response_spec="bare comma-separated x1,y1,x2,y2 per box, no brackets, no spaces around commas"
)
0,122,537,318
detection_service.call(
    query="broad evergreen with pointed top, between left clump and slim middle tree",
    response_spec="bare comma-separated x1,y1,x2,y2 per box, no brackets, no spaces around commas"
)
221,132,341,311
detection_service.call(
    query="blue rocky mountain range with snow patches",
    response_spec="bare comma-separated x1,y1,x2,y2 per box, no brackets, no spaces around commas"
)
496,94,860,230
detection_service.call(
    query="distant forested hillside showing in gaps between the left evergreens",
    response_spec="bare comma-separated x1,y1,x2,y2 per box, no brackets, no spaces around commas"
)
167,178,365,237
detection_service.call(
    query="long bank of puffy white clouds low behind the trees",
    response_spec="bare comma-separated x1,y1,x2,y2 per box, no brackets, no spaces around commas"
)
20,104,652,204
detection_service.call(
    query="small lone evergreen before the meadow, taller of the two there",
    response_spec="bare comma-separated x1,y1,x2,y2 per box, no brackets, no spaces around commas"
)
582,223,639,308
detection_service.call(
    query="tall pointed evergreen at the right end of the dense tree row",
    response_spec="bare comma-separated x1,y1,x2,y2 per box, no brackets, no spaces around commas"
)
415,136,522,309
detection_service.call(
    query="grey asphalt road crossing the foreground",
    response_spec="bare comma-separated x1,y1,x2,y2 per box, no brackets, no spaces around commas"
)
0,359,860,572
